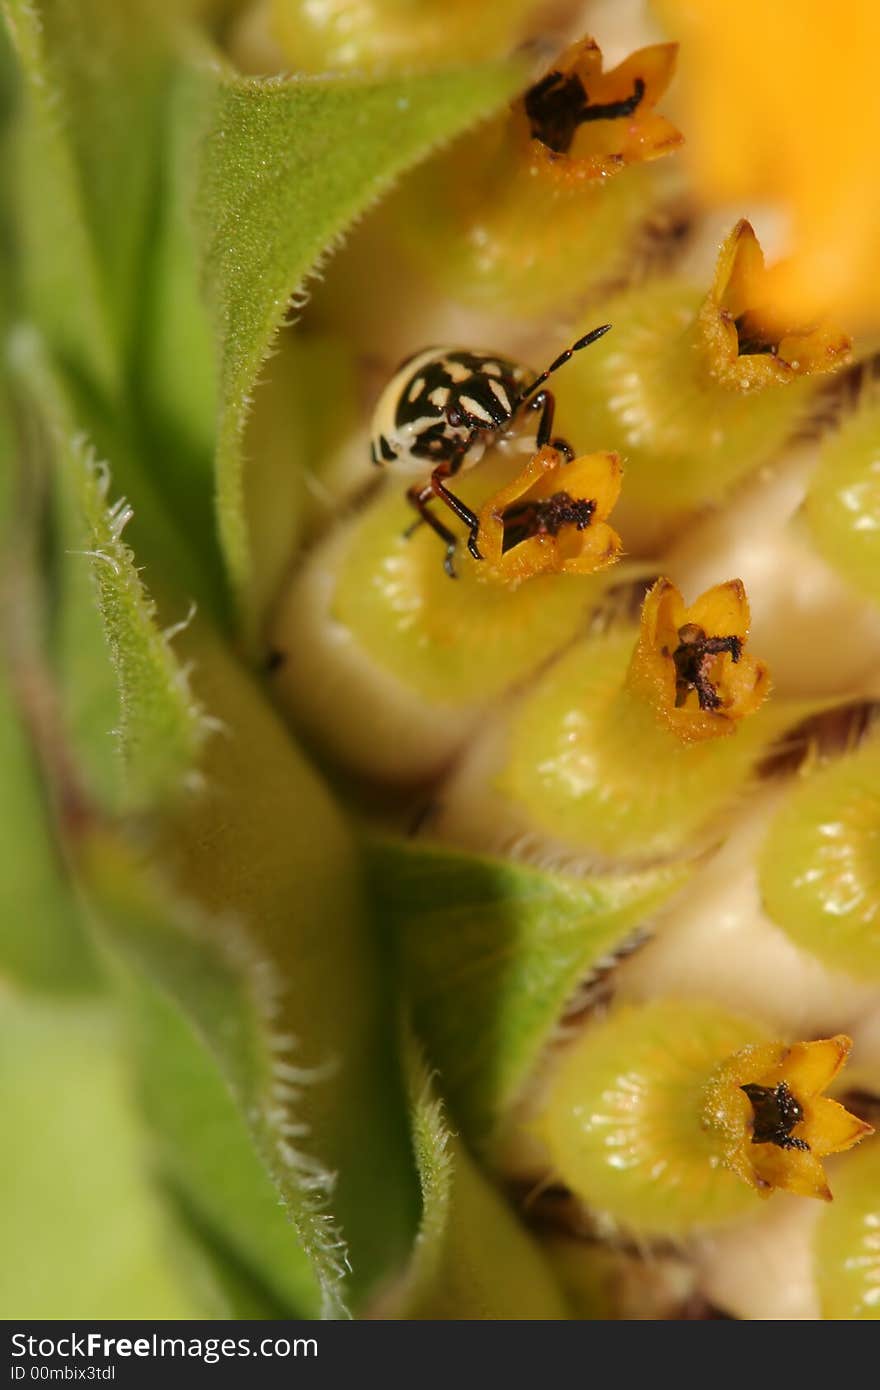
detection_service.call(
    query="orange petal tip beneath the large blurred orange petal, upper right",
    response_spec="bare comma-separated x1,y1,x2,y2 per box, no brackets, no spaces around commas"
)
698,218,852,391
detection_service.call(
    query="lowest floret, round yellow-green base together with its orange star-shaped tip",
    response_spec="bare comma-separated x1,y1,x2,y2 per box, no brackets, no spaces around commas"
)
534,999,870,1237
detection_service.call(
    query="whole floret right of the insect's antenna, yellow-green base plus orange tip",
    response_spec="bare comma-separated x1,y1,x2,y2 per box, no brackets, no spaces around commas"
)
556,222,851,550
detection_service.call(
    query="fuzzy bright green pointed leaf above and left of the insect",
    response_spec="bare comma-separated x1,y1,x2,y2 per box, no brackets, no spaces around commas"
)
196,55,521,619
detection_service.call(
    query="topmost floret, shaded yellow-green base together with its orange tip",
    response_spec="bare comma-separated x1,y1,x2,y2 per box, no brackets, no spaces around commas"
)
396,39,681,322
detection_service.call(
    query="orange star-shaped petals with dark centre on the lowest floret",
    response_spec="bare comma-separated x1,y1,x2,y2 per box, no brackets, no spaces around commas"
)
705,1033,873,1201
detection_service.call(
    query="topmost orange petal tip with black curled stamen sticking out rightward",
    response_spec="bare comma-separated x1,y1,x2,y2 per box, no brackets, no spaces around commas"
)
514,39,683,181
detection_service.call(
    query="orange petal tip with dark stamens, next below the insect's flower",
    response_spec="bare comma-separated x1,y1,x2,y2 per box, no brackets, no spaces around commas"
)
627,580,770,744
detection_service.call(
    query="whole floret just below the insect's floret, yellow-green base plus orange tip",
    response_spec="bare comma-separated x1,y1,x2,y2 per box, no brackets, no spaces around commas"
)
438,581,778,866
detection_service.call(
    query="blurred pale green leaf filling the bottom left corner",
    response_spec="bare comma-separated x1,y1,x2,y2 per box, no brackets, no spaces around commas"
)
0,991,206,1321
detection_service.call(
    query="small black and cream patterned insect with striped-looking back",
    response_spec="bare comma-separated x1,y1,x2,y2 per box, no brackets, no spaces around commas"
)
370,324,612,578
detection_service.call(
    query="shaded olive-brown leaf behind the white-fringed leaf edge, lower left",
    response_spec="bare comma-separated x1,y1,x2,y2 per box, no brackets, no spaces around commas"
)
148,620,416,1302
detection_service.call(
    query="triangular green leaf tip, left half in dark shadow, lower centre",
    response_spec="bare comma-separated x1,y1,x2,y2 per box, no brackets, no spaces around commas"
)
368,842,688,1144
